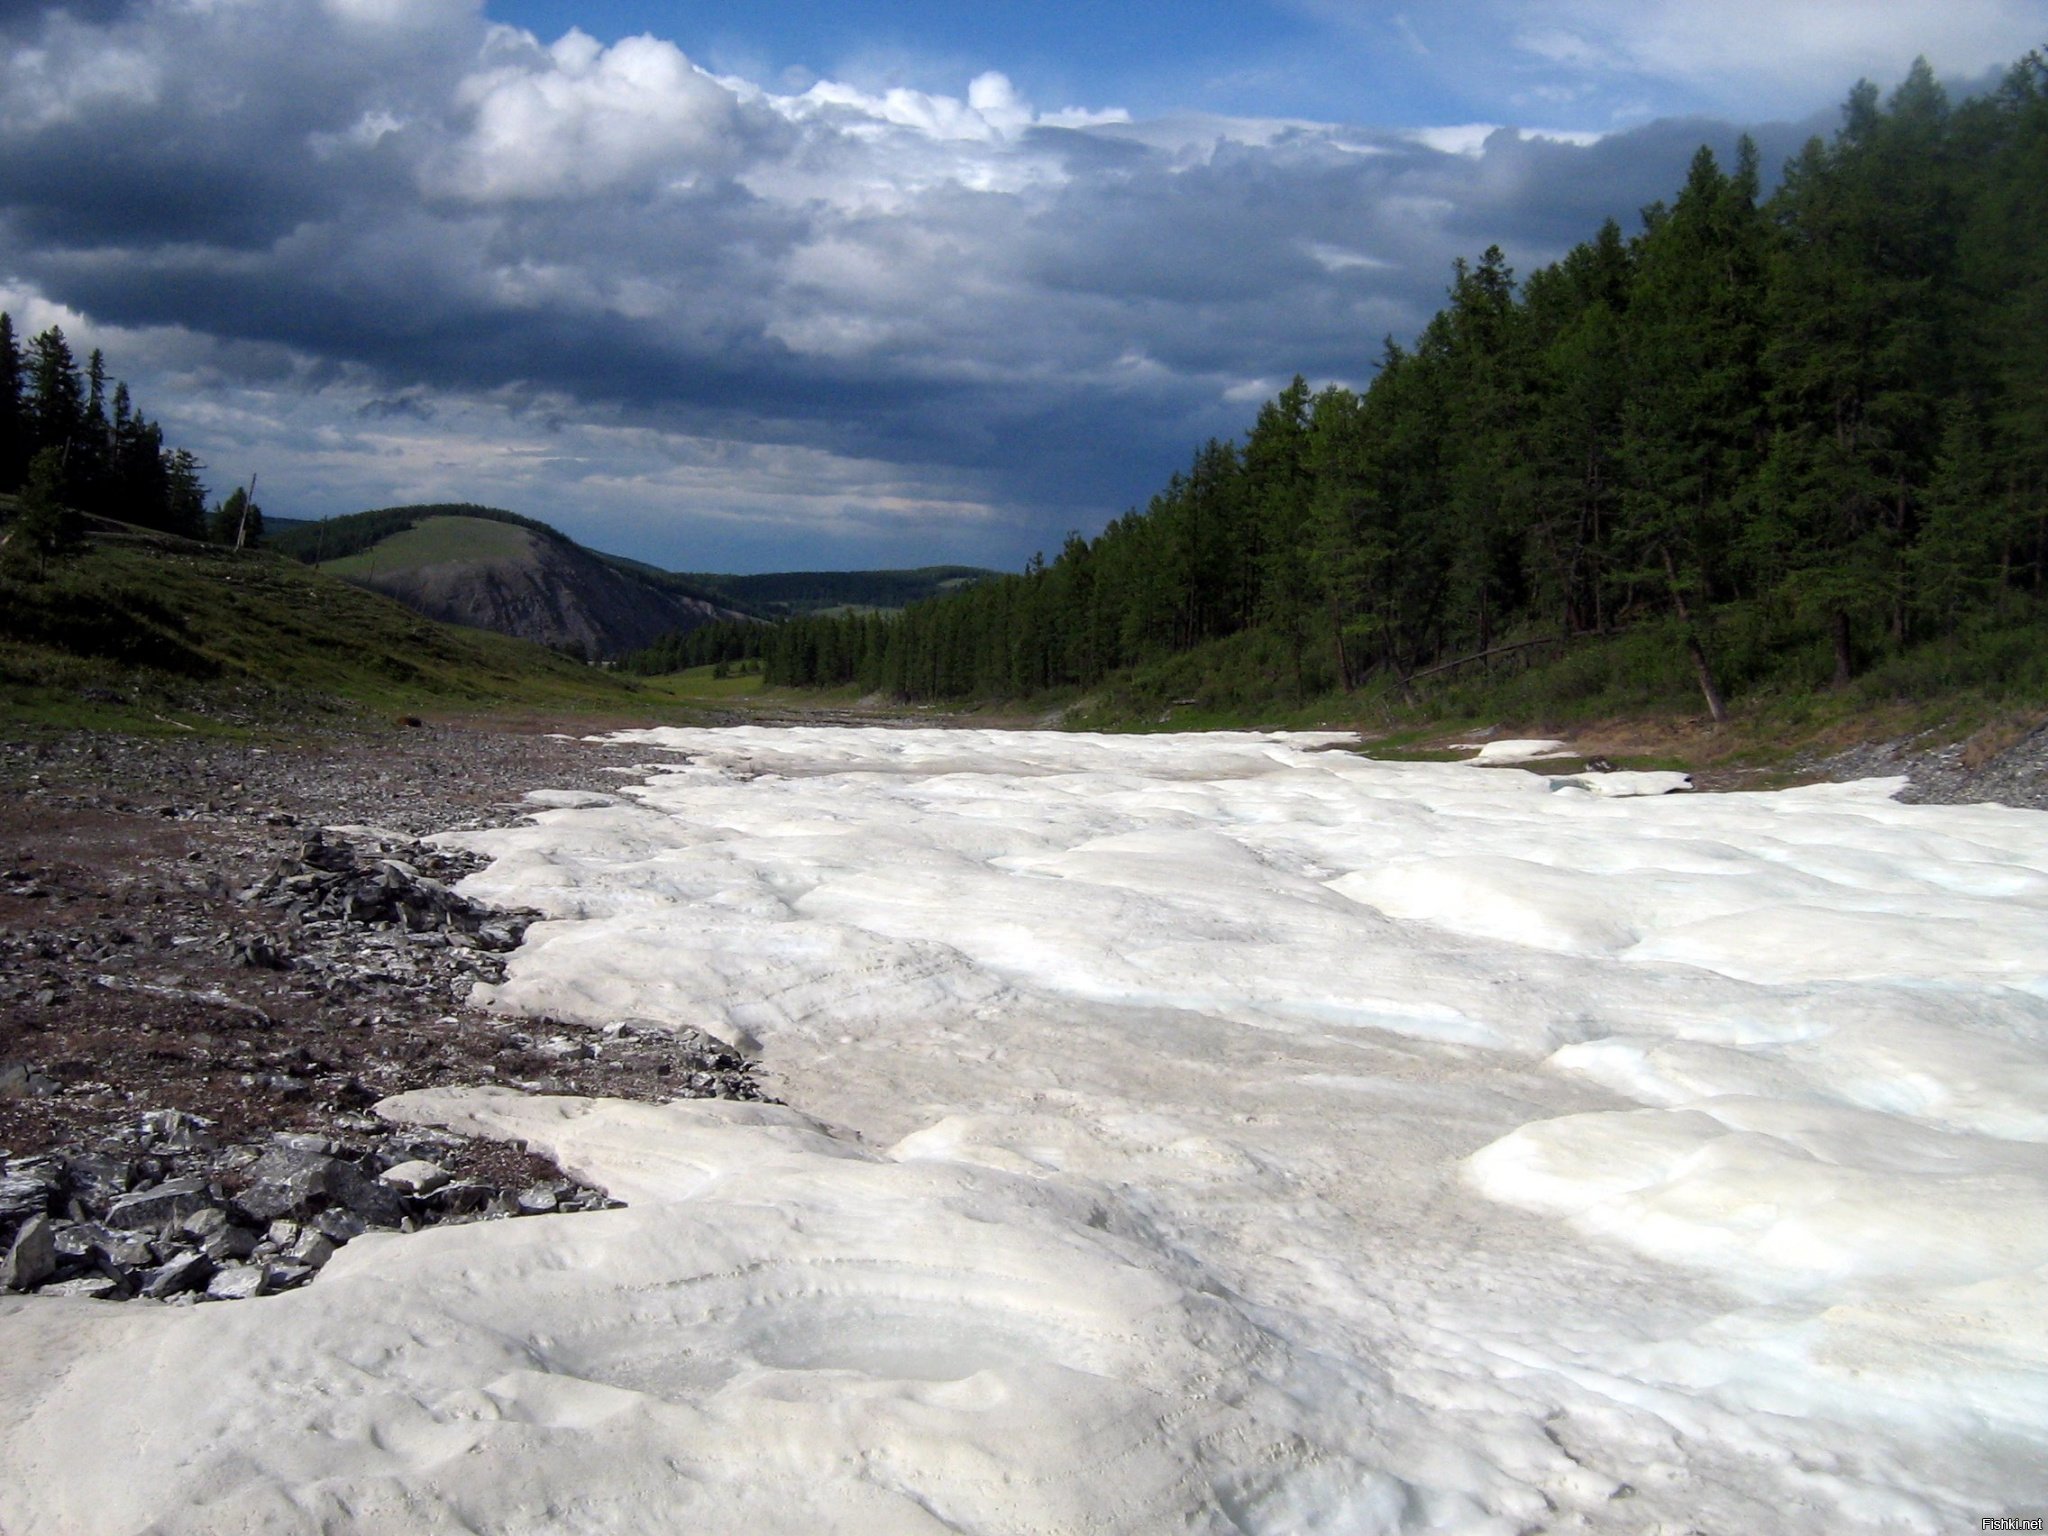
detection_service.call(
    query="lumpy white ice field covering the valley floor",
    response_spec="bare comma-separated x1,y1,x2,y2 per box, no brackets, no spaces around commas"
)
0,729,2048,1536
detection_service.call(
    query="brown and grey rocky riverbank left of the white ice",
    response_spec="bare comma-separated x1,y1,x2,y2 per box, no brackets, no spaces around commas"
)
0,727,762,1300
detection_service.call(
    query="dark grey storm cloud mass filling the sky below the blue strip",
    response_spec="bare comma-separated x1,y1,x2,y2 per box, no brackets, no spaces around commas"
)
0,0,1843,559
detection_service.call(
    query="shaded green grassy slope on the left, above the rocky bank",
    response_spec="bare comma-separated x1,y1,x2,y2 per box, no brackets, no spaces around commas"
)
0,524,688,729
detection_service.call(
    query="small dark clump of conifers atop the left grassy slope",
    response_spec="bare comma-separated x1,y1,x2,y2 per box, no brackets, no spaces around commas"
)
0,313,207,539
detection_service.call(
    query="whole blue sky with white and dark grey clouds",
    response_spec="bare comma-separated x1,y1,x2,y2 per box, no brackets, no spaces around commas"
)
0,0,2048,571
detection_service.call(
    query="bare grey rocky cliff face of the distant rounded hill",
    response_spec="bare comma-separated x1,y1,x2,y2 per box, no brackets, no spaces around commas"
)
354,528,739,657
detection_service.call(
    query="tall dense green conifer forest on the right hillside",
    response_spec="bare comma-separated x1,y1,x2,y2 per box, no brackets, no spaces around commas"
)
762,53,2048,717
